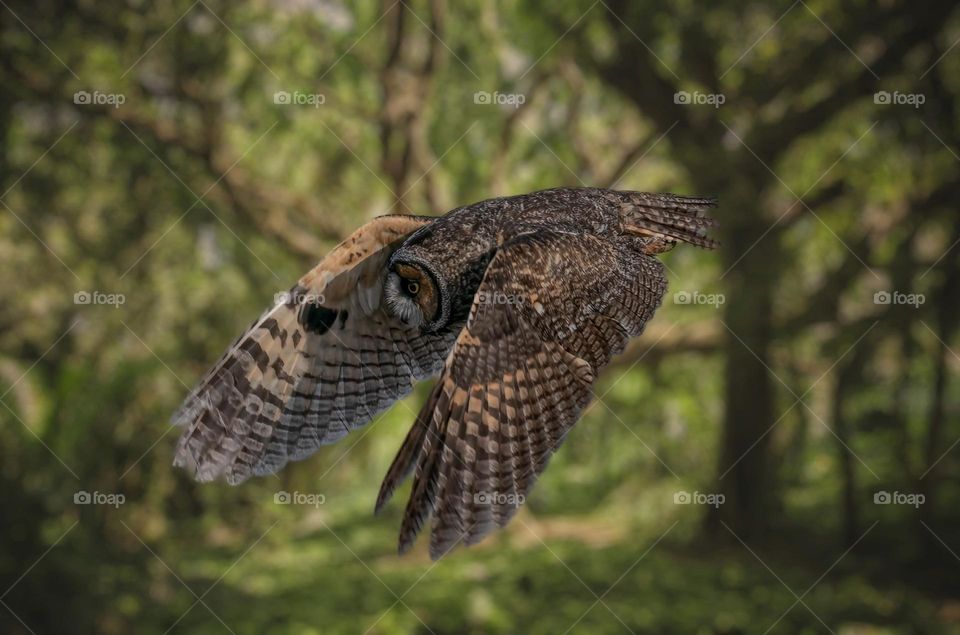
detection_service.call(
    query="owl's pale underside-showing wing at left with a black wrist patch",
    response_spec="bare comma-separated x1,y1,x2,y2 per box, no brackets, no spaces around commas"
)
173,216,456,484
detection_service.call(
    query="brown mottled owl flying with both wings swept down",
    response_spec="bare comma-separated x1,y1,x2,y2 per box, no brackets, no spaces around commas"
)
173,188,717,559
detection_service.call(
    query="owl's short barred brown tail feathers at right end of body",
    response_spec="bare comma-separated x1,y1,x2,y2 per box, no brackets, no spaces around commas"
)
616,192,720,249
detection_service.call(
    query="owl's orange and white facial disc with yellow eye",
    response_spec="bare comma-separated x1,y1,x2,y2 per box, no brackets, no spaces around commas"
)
383,261,449,331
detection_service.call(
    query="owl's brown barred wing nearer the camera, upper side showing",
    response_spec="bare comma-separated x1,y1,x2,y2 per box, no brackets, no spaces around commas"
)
377,231,666,559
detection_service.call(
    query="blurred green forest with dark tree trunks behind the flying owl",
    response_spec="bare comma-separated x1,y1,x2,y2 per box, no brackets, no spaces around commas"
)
0,0,960,635
